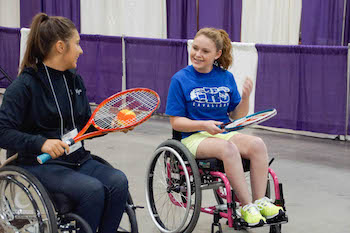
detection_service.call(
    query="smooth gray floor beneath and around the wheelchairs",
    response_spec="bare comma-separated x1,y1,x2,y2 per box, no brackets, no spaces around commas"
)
82,117,350,233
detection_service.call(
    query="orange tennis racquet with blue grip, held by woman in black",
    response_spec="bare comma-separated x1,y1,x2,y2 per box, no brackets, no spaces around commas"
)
37,88,160,164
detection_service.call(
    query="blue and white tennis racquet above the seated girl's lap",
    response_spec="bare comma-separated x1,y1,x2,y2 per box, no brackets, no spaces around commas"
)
219,108,277,132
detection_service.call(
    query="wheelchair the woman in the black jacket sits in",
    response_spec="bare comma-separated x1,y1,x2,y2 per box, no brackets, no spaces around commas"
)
0,148,138,233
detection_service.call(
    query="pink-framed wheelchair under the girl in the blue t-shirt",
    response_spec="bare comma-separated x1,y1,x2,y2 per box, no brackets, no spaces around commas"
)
146,130,288,233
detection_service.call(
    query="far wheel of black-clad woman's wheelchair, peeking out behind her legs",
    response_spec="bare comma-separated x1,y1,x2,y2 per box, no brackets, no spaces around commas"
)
117,193,139,233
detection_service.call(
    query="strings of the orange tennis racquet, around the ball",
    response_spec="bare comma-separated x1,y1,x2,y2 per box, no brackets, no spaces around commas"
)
94,90,158,129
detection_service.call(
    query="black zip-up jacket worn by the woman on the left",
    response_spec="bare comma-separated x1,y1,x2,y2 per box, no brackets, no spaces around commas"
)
0,63,91,165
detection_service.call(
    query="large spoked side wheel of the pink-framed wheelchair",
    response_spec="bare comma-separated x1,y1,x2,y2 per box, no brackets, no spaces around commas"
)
146,139,202,233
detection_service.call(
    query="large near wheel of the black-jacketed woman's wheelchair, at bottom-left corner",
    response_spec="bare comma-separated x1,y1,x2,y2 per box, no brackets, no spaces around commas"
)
0,166,58,233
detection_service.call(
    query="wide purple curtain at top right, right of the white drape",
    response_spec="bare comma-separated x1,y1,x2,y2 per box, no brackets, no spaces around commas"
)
301,0,344,45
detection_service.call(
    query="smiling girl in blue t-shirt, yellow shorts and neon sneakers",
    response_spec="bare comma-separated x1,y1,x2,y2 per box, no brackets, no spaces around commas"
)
166,28,284,226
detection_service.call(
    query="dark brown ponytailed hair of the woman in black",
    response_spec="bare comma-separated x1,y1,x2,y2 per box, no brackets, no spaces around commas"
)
19,13,76,73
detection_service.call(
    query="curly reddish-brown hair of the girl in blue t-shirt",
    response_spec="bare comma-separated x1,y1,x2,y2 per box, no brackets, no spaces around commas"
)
194,28,233,70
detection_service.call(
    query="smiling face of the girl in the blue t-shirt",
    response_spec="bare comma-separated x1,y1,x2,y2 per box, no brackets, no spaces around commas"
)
190,35,222,73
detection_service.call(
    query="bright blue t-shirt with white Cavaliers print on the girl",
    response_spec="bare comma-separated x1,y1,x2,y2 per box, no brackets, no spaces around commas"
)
165,65,241,138
